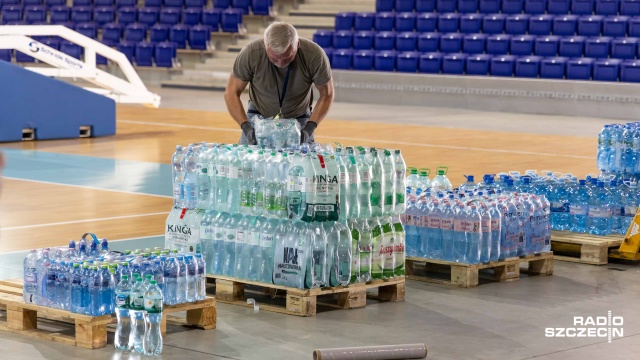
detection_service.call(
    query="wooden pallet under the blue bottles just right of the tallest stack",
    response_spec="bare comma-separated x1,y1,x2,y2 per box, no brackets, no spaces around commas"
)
405,252,554,288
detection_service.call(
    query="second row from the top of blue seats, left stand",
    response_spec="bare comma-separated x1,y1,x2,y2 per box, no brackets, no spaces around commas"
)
0,6,243,32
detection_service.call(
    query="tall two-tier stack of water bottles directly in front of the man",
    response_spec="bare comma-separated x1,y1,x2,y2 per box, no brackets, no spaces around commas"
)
165,143,406,288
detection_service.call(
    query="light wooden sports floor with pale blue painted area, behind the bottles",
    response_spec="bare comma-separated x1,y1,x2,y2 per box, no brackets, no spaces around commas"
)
0,101,596,253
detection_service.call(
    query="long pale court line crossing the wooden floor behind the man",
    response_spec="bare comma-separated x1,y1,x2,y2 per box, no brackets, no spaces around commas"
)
118,120,595,160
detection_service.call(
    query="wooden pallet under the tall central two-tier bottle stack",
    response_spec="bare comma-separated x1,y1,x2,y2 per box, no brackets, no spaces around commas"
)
208,275,405,316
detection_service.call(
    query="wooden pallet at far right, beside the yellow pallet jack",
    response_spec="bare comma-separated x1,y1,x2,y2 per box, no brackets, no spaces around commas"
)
551,230,624,265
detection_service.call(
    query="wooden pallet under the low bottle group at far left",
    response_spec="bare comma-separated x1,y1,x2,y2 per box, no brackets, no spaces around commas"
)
0,280,216,349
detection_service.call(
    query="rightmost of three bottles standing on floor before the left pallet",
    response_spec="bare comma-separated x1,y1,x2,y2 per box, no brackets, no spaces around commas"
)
143,280,163,355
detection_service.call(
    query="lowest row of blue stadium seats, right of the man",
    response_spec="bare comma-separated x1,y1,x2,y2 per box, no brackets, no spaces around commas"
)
325,49,640,82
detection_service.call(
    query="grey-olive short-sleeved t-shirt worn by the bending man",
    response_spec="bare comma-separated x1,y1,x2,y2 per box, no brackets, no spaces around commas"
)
233,38,331,118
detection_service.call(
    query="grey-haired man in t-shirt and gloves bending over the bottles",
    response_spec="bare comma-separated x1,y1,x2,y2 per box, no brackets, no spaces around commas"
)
224,22,333,145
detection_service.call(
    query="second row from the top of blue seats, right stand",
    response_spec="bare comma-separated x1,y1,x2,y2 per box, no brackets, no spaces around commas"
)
335,11,640,36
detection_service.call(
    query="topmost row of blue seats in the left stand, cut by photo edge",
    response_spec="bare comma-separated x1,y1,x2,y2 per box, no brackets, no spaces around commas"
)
0,0,273,15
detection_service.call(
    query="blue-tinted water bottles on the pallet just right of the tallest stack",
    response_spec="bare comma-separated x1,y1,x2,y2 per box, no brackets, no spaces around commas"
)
403,169,550,264
